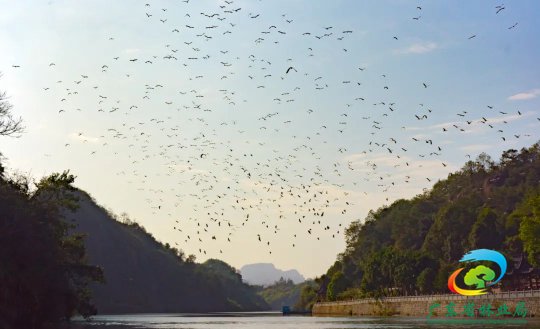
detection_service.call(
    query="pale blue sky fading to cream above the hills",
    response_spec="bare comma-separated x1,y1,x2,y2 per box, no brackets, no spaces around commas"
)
0,0,540,278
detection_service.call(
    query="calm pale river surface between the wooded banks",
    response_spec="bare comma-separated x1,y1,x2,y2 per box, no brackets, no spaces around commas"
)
72,313,540,329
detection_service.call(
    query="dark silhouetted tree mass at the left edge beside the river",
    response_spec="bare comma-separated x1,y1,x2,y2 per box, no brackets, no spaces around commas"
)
0,168,103,328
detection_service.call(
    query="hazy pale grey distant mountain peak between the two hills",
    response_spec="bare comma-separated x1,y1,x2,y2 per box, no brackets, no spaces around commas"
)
240,263,305,286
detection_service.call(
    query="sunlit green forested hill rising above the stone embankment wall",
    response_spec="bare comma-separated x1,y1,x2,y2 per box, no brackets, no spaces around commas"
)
312,143,540,300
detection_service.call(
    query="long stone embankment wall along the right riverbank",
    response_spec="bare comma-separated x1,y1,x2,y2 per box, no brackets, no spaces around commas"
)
312,290,540,317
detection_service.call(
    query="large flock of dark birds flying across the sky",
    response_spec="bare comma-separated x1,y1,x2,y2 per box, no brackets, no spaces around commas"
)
7,0,540,257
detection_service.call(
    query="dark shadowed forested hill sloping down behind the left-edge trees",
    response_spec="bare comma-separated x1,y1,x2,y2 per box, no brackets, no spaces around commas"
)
66,191,269,314
